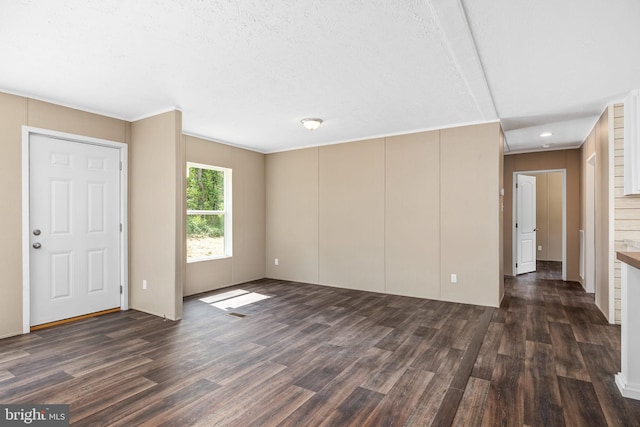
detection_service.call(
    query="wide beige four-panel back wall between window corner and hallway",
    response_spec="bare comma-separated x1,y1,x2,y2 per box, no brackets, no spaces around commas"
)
266,123,502,306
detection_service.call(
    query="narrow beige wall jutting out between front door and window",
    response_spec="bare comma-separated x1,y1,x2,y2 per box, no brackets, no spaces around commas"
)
129,111,185,320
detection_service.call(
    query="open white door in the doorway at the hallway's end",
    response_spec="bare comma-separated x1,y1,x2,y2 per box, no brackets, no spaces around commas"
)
516,174,536,274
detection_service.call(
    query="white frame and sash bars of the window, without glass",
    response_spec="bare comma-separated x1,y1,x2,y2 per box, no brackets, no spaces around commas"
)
185,162,233,263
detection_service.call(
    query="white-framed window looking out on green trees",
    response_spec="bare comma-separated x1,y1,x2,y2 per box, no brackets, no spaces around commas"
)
187,163,232,262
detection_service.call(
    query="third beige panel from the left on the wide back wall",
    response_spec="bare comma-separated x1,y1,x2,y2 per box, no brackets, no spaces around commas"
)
385,131,441,299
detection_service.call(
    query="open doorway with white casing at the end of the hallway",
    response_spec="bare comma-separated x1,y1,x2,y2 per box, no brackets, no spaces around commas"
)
512,169,567,281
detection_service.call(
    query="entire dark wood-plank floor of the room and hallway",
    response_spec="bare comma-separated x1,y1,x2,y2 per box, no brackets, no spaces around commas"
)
0,263,640,426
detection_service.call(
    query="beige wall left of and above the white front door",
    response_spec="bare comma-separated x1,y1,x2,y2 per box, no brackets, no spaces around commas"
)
0,93,129,338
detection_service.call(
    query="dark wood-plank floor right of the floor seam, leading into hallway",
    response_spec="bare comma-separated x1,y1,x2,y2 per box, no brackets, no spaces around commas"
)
478,262,640,426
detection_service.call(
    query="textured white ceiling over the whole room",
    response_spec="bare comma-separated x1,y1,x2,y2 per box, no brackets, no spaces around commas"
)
0,0,640,152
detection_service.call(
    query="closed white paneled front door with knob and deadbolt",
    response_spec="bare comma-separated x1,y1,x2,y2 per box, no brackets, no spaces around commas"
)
29,134,121,326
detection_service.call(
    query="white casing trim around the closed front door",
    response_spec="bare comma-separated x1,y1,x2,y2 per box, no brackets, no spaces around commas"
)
22,126,129,334
